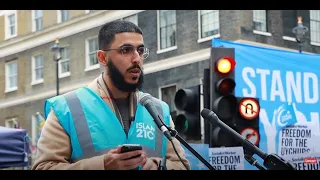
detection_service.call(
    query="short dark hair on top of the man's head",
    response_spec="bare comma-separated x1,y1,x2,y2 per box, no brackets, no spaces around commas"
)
98,20,142,50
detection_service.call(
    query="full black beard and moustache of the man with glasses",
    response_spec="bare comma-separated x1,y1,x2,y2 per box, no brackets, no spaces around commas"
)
107,59,144,92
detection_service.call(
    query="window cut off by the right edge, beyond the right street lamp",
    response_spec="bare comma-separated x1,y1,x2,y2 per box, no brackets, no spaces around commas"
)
310,10,320,45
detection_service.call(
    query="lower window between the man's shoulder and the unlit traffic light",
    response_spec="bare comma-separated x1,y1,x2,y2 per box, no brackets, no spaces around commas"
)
159,85,177,119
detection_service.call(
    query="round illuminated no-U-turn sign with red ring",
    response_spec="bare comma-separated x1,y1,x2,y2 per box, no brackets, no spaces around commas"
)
239,98,260,120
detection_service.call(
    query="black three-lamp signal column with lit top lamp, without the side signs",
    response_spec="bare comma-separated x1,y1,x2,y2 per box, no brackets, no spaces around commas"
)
209,47,238,147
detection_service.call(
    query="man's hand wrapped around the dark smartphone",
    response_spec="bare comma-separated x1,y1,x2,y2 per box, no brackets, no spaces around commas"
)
104,146,147,170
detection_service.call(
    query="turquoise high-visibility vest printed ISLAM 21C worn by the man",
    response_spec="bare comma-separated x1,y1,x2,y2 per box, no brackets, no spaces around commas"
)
44,87,170,165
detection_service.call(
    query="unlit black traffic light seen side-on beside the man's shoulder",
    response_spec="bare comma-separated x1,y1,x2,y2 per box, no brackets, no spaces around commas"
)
174,85,201,140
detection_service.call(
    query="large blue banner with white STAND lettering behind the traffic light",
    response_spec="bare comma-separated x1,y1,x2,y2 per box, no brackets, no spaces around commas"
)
212,39,320,169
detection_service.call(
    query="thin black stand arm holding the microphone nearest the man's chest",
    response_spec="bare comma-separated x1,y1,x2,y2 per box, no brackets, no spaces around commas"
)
168,123,216,170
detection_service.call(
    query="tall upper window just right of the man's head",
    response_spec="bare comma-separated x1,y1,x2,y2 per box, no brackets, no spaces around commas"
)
158,10,177,49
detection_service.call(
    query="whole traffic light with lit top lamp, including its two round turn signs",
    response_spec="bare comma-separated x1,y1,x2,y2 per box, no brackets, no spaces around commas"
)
203,47,260,149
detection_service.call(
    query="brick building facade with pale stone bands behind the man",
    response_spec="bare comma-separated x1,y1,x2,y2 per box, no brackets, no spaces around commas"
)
0,10,320,148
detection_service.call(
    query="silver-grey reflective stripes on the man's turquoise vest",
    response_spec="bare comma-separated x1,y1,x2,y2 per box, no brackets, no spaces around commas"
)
64,91,169,161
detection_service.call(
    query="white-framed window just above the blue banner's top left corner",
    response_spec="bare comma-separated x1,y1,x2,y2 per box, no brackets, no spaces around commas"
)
199,10,220,39
